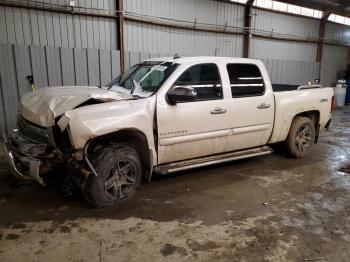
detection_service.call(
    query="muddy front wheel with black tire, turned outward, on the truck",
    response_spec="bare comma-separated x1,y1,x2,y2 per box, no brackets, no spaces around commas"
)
83,144,142,208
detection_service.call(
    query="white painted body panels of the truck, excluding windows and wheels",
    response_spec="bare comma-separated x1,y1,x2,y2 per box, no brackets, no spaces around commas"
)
20,57,333,168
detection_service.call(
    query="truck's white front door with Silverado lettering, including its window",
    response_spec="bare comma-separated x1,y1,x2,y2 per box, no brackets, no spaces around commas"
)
157,63,230,164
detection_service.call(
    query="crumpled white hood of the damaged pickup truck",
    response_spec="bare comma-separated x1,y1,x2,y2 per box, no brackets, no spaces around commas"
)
19,86,132,127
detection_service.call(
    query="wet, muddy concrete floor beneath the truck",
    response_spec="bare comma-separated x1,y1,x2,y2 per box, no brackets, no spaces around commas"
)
0,107,350,261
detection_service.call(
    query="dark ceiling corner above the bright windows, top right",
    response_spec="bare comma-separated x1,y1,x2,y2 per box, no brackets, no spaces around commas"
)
278,0,350,17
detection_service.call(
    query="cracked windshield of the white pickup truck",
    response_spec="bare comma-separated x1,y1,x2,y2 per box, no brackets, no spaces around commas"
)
106,61,178,98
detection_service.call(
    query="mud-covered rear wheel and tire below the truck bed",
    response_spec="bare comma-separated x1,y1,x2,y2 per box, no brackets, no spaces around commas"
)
286,116,315,158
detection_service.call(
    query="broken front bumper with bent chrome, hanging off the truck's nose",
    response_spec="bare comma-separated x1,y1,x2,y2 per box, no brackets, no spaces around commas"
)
1,129,57,184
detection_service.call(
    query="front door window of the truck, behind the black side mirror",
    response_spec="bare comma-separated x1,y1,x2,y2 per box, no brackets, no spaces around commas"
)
174,64,223,101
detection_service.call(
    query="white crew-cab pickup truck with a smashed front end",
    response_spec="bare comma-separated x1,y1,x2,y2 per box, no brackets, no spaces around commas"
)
3,57,333,207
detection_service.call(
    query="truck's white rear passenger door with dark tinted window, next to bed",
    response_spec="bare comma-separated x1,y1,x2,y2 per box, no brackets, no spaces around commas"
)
226,63,275,151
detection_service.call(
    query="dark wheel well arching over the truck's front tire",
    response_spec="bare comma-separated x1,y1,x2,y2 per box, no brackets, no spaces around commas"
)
88,129,152,179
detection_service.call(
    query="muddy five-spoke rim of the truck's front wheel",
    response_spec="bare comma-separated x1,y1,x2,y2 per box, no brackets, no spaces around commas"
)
105,159,137,200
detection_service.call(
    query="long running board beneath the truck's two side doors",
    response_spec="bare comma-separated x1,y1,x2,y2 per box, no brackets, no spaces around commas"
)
154,146,273,174
